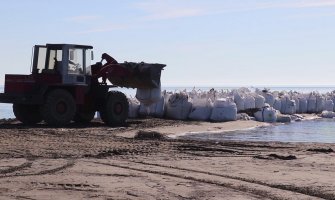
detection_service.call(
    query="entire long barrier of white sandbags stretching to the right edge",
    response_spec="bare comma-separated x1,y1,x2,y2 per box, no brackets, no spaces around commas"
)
129,88,335,122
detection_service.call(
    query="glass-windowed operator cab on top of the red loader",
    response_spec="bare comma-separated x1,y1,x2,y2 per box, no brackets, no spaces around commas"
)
32,44,93,85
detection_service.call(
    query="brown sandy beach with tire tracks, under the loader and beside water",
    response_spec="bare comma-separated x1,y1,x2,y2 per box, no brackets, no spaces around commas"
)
0,118,335,199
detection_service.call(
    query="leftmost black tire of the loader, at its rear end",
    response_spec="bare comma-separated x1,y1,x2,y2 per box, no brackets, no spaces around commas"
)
13,104,42,125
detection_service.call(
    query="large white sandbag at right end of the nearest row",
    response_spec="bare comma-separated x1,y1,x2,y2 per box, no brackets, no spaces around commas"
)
210,99,237,122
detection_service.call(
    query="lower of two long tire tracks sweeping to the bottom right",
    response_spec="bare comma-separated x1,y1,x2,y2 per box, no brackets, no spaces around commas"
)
85,161,320,200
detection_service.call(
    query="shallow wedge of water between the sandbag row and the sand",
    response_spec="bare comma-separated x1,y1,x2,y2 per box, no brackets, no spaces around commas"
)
179,119,335,143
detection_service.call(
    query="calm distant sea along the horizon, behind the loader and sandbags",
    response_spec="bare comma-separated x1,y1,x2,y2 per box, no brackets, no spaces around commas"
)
0,86,335,119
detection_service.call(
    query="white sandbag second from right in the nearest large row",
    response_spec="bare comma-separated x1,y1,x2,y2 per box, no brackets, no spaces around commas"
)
188,98,213,121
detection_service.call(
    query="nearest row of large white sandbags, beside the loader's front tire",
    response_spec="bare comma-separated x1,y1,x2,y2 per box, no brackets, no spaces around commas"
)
129,92,237,121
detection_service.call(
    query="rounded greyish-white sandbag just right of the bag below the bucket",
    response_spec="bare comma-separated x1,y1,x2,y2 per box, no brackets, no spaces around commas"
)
166,93,192,120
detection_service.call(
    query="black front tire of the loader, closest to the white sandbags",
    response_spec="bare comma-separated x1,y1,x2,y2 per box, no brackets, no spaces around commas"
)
100,91,129,126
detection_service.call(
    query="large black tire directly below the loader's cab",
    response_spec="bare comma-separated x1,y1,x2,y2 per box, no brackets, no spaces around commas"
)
41,89,76,126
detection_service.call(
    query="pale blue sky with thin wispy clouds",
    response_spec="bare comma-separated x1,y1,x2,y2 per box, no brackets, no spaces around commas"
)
0,0,335,86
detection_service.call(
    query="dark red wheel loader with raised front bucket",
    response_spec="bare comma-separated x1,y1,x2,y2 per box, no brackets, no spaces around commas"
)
0,44,165,126
